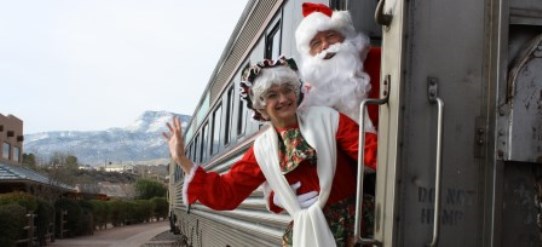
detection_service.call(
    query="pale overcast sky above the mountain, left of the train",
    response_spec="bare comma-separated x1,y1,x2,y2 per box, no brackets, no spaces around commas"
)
0,0,247,134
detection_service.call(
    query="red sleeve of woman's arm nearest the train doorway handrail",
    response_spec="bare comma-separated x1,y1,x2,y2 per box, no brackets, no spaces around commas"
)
336,113,377,170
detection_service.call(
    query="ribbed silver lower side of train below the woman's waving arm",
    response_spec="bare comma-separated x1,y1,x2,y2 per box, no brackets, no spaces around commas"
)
173,149,291,246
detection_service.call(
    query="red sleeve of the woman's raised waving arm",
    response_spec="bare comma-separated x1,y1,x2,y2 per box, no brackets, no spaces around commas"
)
185,147,265,210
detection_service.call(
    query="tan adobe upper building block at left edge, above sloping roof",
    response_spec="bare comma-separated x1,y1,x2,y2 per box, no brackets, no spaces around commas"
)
0,114,24,164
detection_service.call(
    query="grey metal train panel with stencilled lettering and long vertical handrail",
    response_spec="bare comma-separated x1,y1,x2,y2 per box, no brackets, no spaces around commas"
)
375,0,494,246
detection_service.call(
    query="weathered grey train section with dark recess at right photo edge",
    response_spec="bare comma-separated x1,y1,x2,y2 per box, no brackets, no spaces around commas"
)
498,0,542,246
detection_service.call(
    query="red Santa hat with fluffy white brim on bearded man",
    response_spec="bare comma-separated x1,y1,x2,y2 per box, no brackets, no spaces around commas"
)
295,3,357,55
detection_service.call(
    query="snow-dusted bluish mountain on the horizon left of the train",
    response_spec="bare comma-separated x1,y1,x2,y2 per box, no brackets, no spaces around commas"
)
24,111,190,164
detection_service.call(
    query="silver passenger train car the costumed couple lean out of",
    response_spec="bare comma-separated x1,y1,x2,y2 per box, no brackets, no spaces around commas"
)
169,0,542,247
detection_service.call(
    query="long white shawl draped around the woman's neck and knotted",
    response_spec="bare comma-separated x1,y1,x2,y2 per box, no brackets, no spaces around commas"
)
254,107,339,247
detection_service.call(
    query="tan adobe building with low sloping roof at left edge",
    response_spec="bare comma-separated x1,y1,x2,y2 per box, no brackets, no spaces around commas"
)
0,114,75,195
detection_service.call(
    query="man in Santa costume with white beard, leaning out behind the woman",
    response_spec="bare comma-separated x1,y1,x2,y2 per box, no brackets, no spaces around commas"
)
295,3,380,133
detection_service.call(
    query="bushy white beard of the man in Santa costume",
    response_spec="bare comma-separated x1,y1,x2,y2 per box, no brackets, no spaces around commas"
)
300,36,376,133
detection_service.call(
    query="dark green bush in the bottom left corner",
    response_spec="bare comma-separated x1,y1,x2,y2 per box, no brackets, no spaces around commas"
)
0,203,28,246
